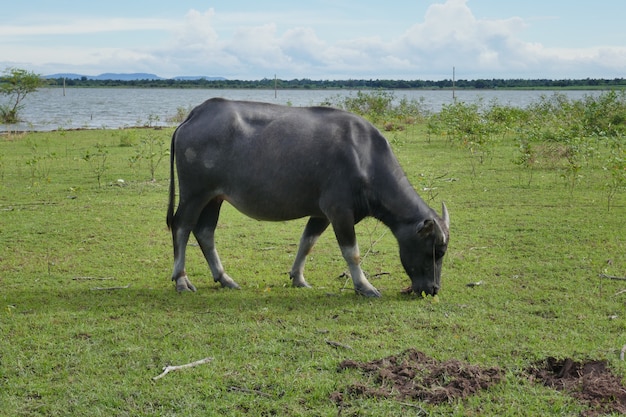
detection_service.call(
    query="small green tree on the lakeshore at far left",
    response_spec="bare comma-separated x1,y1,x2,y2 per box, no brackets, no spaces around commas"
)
0,68,44,124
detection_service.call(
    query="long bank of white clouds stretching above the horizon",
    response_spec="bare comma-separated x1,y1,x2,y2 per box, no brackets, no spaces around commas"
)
0,0,626,79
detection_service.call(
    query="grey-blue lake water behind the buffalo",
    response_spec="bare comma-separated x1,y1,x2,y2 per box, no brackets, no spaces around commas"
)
0,88,601,131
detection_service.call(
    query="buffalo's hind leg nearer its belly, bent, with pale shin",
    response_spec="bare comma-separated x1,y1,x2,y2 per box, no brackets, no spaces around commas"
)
193,199,240,289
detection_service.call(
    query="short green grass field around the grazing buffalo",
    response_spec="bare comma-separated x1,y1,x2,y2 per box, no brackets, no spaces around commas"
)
0,125,626,416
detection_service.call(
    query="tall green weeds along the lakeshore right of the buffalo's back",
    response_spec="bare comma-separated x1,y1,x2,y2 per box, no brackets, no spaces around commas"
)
336,91,626,205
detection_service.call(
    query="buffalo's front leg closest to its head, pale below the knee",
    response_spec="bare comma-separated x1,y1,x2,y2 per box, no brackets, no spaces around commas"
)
332,215,380,297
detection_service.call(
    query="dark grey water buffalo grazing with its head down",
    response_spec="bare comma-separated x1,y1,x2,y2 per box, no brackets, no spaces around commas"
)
167,98,450,297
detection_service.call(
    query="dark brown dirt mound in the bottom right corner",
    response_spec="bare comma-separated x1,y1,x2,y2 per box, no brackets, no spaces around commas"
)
527,358,626,416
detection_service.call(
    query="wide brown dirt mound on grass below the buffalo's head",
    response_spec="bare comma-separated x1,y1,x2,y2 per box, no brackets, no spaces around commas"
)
331,349,503,405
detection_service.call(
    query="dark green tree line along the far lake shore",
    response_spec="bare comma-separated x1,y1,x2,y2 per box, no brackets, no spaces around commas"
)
46,77,626,90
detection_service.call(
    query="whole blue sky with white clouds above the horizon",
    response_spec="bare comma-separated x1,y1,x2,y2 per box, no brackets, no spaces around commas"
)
0,0,626,80
